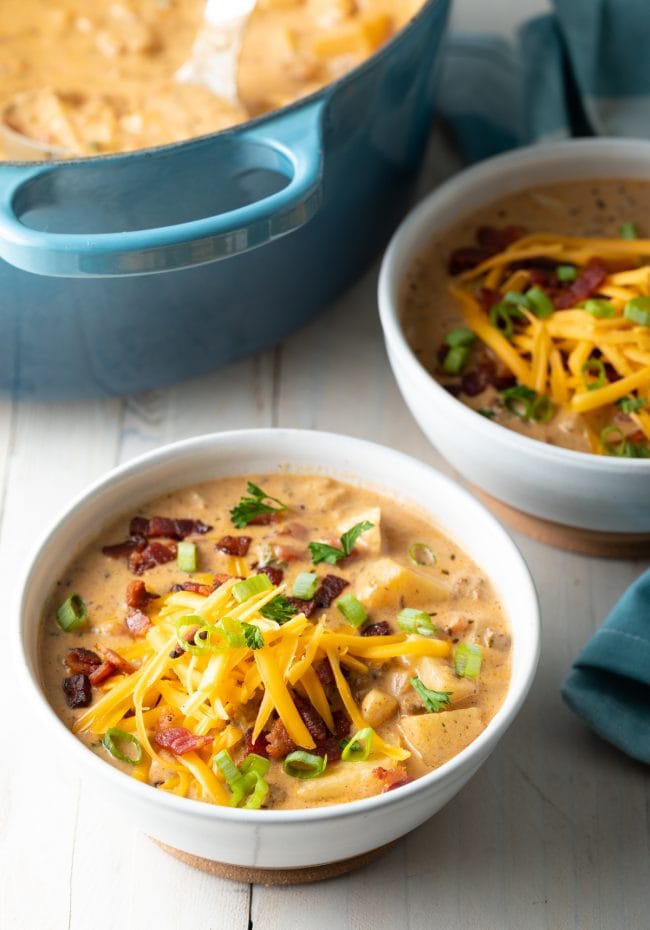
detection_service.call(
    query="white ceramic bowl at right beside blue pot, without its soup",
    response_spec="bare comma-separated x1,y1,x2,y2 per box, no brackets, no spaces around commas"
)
379,139,650,533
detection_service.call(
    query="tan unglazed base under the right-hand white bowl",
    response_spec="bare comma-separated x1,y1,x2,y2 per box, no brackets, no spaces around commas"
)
472,487,650,559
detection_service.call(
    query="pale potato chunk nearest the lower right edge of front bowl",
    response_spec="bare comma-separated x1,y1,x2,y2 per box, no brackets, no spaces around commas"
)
400,707,483,768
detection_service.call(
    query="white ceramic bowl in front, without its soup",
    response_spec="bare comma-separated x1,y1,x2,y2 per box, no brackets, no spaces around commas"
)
14,430,539,868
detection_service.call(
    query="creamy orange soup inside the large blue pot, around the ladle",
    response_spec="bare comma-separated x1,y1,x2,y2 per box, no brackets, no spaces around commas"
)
0,0,421,155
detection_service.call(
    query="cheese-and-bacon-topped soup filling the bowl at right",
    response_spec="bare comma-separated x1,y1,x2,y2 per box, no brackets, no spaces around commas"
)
402,181,650,458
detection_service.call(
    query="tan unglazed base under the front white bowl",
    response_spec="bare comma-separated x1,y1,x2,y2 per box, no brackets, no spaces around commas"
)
149,836,397,885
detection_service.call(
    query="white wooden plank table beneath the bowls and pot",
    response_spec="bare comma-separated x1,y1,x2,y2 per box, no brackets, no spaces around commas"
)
0,0,650,930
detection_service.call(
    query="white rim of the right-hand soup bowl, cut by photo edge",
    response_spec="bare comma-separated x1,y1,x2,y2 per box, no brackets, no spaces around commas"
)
377,137,650,477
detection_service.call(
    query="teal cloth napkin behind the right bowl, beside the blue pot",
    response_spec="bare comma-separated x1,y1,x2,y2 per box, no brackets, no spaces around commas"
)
440,0,650,161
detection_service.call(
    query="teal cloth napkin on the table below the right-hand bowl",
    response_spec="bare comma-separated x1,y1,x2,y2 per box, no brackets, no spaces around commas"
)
562,570,650,763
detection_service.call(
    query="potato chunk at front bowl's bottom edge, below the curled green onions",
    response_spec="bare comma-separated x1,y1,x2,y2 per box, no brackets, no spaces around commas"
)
292,756,403,806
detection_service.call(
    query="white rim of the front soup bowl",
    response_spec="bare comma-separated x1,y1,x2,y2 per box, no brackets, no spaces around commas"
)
11,427,541,827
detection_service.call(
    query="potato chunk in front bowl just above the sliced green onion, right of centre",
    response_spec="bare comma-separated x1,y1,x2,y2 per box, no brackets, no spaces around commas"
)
355,558,448,610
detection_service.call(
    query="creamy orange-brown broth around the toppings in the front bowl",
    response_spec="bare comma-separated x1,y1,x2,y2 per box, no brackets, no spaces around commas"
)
40,474,510,808
